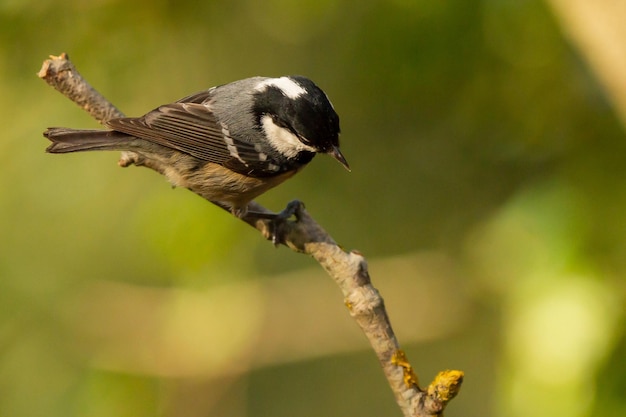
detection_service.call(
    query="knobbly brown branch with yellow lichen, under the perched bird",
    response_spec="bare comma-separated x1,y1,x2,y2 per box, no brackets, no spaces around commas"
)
38,54,463,417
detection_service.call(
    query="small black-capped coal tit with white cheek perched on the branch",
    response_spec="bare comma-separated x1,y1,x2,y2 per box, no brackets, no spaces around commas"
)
44,76,349,217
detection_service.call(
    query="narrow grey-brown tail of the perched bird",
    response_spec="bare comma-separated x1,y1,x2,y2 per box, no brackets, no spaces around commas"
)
43,127,135,153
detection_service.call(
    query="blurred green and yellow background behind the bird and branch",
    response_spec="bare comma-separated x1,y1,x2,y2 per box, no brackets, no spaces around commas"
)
0,0,626,417
